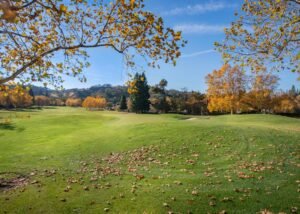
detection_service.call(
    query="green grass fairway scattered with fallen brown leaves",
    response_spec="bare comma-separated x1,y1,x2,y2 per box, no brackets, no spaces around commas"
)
0,108,300,213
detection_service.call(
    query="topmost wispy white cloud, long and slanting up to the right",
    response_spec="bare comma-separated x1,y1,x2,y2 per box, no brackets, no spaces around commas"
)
163,1,237,16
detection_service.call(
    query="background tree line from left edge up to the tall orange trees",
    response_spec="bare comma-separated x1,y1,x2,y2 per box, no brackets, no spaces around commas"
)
0,73,207,114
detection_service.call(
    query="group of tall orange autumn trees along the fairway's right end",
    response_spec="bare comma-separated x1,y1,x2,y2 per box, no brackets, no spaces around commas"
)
206,64,300,114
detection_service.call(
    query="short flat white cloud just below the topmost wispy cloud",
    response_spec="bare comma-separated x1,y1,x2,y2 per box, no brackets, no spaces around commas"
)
174,24,228,34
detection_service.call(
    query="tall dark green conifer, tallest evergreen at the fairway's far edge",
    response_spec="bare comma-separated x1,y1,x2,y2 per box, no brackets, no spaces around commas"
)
130,73,150,113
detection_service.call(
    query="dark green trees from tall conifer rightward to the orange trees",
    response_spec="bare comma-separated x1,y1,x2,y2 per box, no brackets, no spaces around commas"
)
127,73,208,114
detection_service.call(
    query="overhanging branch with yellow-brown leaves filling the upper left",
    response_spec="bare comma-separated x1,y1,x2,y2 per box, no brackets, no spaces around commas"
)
0,0,186,86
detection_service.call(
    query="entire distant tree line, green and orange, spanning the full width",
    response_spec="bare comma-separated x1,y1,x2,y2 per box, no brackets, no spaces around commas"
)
0,69,300,115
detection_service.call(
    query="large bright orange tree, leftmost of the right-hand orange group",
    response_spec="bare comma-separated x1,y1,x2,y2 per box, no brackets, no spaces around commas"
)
206,64,246,114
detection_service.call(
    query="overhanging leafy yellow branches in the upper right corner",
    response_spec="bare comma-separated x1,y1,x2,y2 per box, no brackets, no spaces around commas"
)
216,0,300,75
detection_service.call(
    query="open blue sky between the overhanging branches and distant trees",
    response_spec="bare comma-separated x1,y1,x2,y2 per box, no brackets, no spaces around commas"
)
64,0,300,92
